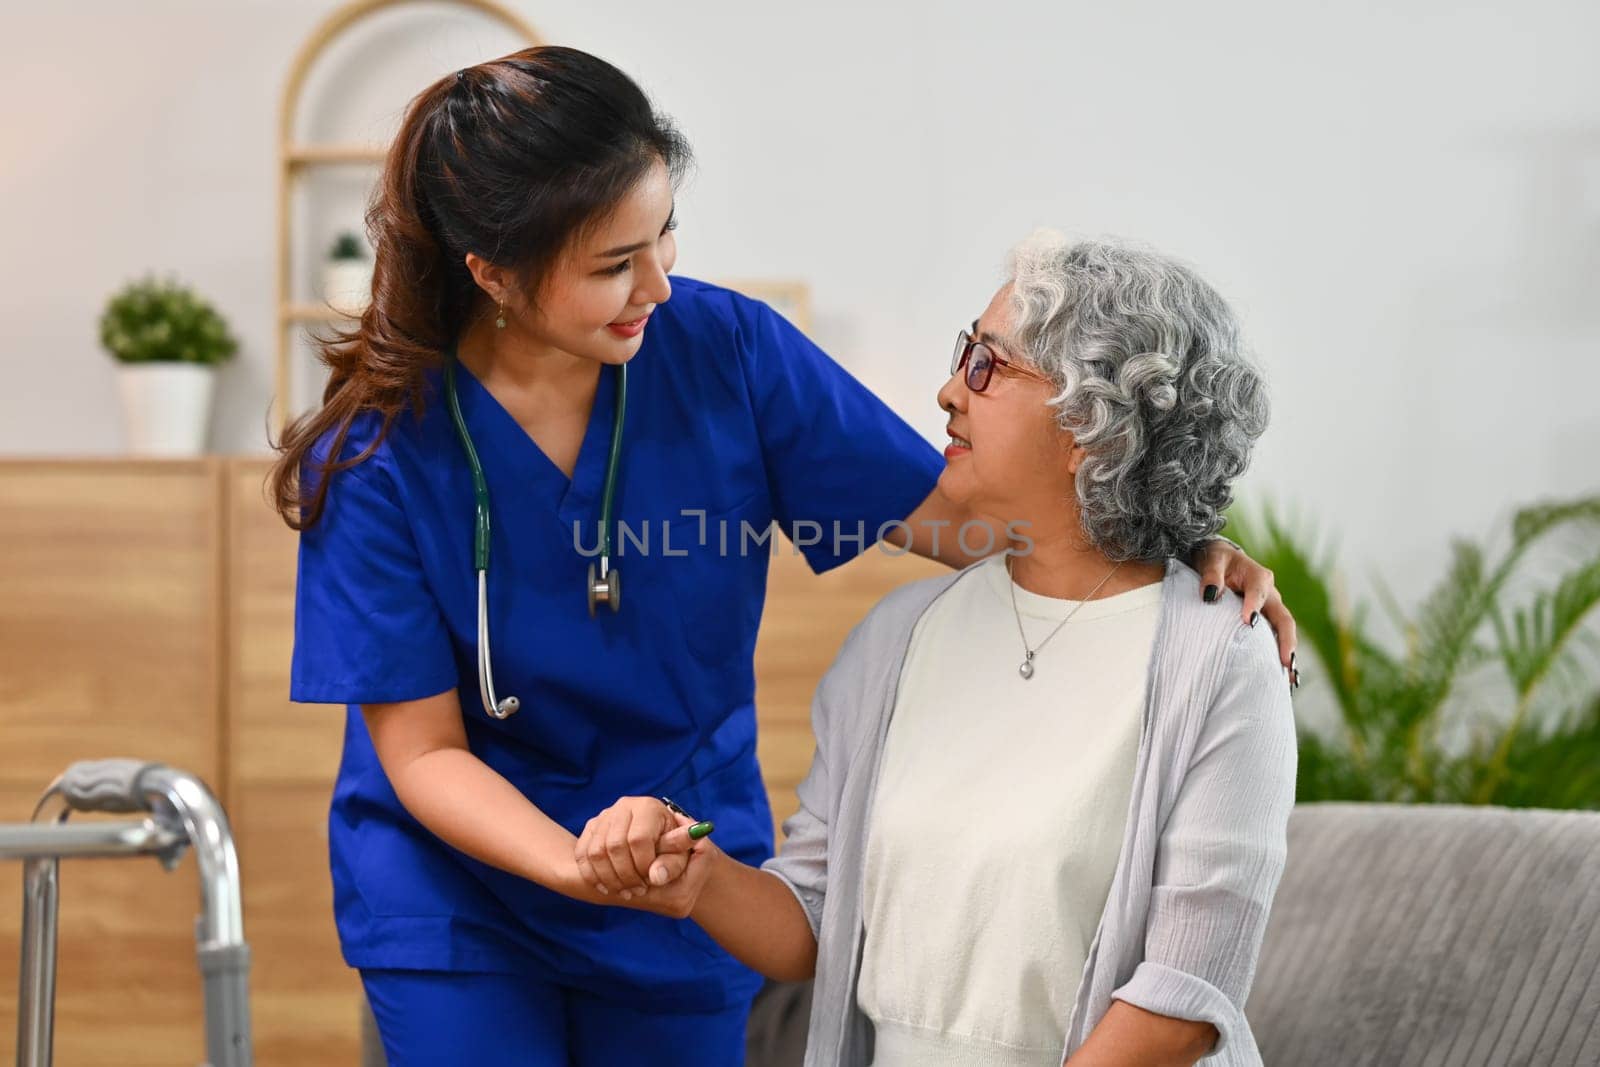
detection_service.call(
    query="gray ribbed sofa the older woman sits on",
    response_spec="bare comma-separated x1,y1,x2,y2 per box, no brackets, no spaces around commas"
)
366,803,1600,1067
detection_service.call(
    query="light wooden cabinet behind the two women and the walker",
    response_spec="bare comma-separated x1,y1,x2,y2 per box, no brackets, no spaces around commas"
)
0,458,941,1067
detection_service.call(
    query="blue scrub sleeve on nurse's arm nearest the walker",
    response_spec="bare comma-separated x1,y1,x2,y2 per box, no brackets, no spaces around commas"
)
290,459,459,704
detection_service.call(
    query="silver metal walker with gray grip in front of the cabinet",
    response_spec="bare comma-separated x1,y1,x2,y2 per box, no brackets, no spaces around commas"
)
0,760,251,1067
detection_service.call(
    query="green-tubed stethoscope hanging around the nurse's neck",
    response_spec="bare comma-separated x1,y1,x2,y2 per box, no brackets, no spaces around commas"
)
445,352,627,718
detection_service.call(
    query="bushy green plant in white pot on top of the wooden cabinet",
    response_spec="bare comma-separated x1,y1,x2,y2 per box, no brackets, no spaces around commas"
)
101,278,238,456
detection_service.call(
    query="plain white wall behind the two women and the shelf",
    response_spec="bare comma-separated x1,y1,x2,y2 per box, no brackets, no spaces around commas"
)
0,0,1600,604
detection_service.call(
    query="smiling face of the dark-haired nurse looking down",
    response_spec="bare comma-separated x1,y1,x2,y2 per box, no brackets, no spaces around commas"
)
467,160,678,363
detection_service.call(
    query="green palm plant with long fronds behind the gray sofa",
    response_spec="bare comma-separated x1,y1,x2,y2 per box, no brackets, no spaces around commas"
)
1229,498,1600,808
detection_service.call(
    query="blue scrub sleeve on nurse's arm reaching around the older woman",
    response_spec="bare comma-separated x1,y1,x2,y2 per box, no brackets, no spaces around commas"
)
734,298,944,574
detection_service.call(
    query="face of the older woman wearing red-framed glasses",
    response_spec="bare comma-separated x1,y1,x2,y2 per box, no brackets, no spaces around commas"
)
939,285,1077,528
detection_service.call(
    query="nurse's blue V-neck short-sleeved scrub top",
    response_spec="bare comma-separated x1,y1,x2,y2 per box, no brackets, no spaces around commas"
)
290,278,944,1011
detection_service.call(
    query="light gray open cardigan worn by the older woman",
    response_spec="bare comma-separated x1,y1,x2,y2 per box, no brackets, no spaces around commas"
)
765,561,1298,1067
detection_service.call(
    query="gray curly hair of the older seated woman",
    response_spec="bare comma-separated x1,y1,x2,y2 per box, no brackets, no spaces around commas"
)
1010,230,1267,560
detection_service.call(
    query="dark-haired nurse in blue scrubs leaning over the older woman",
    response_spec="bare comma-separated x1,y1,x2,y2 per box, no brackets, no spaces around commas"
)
272,48,1293,1067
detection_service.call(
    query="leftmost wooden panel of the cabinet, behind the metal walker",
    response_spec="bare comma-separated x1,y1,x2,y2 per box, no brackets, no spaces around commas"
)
0,461,224,1067
